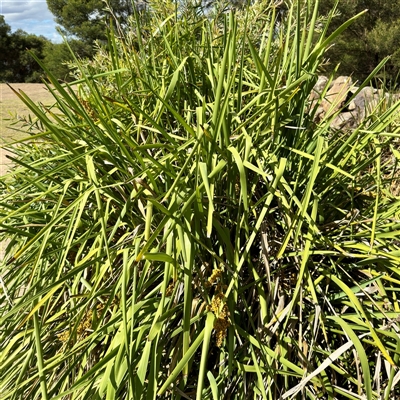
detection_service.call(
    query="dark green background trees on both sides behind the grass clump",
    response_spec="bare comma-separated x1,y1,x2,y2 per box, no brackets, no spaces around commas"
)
0,0,400,88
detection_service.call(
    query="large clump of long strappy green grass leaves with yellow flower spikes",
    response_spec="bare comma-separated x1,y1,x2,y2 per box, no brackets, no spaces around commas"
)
0,0,400,400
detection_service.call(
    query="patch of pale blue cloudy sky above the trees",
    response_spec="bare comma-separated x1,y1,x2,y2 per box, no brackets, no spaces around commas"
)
0,0,62,42
